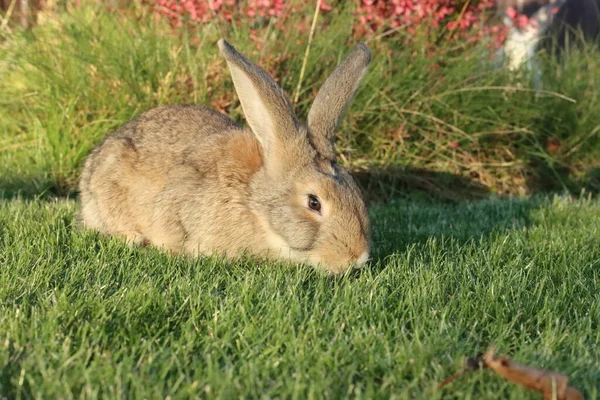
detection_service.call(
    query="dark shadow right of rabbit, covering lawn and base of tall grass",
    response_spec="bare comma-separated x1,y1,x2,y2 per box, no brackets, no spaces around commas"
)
354,168,556,269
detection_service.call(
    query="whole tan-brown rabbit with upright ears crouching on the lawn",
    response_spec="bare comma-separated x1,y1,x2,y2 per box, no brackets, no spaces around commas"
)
79,39,371,274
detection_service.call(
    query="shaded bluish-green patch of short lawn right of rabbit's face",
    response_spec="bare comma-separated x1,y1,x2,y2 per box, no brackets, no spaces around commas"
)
364,196,551,271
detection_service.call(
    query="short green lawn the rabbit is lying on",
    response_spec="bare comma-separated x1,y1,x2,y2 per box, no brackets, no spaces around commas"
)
0,197,600,399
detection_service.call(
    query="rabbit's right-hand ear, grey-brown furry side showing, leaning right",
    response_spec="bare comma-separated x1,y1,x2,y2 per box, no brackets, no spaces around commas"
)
308,43,371,160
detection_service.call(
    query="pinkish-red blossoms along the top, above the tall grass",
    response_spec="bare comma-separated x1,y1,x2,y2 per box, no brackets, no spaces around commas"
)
145,0,504,47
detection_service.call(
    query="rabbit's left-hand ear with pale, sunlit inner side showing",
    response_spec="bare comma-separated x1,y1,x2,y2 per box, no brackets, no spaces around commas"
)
218,39,299,160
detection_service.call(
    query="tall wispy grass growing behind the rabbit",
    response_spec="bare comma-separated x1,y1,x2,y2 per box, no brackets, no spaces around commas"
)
0,3,600,195
